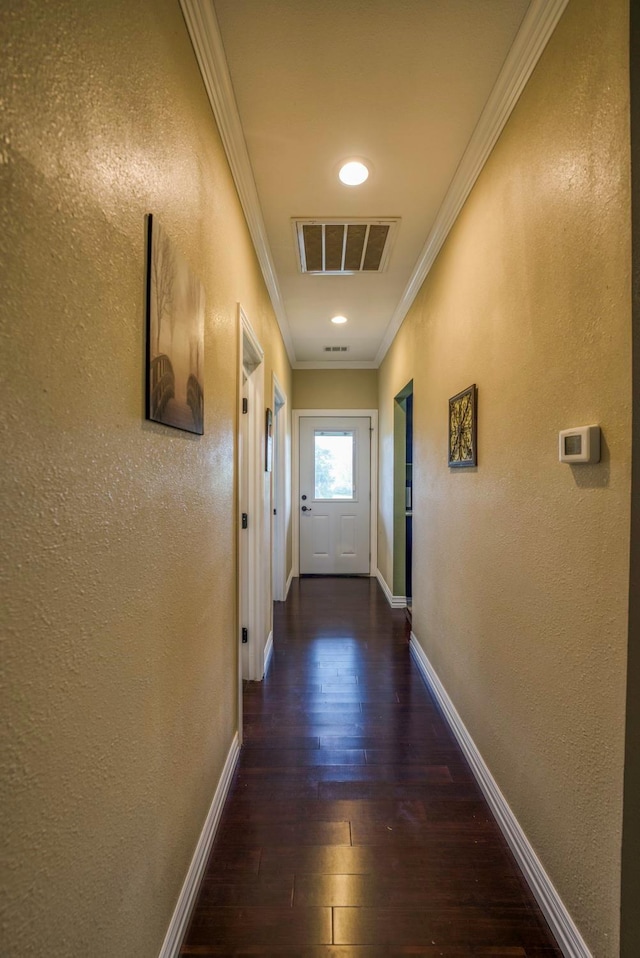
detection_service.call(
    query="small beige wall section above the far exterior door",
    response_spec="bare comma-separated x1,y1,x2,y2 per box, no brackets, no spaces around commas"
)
293,369,378,409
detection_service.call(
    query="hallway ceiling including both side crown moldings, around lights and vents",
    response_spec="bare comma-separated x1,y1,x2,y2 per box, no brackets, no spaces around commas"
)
181,0,567,368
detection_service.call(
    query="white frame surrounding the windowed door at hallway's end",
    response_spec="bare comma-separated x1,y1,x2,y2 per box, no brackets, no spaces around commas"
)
291,409,378,576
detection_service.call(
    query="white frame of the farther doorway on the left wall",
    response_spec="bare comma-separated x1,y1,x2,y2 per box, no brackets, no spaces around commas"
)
271,373,291,602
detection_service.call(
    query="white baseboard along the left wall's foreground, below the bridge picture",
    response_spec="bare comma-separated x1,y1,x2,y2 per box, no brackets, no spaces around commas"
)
159,732,240,958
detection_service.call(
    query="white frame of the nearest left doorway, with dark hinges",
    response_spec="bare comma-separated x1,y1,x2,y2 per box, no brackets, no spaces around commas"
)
236,303,270,741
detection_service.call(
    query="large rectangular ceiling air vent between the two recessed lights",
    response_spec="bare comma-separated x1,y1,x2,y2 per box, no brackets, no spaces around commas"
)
294,218,399,276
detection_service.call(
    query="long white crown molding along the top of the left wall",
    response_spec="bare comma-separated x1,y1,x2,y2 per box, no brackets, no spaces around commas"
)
180,0,295,364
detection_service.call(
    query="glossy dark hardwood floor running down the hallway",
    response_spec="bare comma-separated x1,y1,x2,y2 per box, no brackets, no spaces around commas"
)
181,578,561,958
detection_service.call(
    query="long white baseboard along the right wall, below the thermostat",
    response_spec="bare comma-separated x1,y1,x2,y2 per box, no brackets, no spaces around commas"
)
409,632,593,958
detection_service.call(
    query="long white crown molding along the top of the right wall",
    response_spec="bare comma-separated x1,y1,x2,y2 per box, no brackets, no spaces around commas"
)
376,0,569,366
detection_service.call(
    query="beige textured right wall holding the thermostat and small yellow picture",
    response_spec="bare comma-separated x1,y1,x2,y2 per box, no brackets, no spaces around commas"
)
380,0,631,958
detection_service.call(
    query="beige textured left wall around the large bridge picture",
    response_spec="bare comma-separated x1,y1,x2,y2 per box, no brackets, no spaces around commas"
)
0,0,291,958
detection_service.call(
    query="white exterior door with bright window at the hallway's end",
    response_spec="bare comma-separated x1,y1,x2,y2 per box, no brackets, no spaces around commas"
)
298,416,371,575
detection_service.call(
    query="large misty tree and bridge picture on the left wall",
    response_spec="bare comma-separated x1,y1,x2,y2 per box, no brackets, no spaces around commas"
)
146,214,204,435
